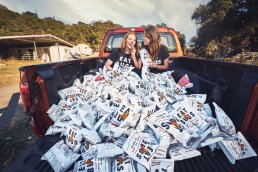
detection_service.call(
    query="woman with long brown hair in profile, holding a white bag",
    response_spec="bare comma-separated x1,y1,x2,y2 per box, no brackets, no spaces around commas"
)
140,26,169,73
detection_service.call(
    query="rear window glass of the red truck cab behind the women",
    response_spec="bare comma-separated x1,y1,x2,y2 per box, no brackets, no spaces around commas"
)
105,32,177,52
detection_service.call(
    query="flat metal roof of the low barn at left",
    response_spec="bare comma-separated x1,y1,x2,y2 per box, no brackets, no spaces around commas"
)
0,34,74,47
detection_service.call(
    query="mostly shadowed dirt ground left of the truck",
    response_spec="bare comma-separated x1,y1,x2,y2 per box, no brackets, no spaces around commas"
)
0,84,37,171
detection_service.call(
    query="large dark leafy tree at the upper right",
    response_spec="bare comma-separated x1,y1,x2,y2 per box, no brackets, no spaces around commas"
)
191,0,258,57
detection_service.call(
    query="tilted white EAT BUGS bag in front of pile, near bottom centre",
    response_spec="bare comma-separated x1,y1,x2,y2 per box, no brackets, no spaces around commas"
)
123,130,157,169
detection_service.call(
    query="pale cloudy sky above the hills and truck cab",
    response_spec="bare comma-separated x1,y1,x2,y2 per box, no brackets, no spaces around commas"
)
0,0,209,42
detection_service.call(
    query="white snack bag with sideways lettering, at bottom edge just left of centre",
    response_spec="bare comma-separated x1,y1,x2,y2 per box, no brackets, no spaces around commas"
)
112,153,135,172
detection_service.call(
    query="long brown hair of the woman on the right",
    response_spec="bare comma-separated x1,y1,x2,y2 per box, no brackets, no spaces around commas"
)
142,25,161,61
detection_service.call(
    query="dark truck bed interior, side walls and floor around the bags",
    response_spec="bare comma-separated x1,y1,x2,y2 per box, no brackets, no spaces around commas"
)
6,57,258,172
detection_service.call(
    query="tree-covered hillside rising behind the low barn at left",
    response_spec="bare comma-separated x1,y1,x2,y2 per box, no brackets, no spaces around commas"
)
0,4,121,50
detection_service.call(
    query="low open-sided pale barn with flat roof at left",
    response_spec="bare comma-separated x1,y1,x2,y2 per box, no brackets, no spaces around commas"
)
0,34,74,62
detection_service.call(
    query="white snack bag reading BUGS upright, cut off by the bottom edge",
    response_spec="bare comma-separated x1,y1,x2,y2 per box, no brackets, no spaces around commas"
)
73,158,111,172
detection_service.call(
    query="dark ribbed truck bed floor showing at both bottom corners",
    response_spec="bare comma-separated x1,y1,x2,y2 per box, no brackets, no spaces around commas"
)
6,135,258,172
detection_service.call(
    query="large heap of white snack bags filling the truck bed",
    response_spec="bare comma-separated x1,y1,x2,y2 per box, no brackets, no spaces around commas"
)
41,66,256,172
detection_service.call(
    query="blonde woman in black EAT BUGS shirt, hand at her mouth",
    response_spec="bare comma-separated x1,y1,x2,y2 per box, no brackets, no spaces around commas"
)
105,32,142,70
